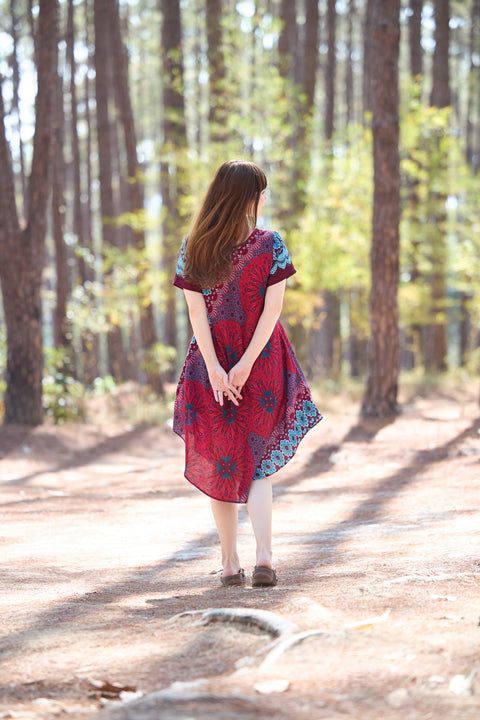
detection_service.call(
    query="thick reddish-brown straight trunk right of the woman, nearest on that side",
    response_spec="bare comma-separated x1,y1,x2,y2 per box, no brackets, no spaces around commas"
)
362,0,400,417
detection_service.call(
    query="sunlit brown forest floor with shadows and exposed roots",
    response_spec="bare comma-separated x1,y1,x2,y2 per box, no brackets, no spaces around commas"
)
0,386,480,720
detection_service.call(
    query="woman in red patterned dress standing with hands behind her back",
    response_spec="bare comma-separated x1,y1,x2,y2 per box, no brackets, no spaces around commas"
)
173,160,321,587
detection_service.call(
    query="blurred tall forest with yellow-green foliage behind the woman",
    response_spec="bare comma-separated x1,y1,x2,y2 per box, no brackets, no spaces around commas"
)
0,0,480,424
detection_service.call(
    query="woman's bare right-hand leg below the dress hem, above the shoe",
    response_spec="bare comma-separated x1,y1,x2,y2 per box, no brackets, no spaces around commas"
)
247,478,273,568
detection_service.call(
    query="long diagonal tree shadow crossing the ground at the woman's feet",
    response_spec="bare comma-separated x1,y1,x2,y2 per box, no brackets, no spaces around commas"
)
2,410,480,688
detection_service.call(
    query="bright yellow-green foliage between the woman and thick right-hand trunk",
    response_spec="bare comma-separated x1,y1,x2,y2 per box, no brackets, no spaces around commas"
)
287,128,373,327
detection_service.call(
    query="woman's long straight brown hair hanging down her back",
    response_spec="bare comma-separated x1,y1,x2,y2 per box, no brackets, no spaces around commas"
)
184,160,267,287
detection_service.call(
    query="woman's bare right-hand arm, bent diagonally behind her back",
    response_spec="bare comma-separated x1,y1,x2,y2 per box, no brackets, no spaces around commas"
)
228,280,287,392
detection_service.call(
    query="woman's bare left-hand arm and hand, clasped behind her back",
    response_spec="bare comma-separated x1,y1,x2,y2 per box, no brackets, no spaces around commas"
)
183,289,242,405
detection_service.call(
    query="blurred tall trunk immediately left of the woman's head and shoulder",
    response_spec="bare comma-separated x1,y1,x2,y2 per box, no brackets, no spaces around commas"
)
160,0,187,358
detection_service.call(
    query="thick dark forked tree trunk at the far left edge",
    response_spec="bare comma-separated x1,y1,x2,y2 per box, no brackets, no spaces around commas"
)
0,0,58,425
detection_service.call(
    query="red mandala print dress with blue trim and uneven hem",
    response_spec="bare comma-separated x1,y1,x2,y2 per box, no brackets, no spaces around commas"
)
173,229,322,503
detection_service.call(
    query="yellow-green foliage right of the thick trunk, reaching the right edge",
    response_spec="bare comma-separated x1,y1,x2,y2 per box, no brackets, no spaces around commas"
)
399,86,480,332
